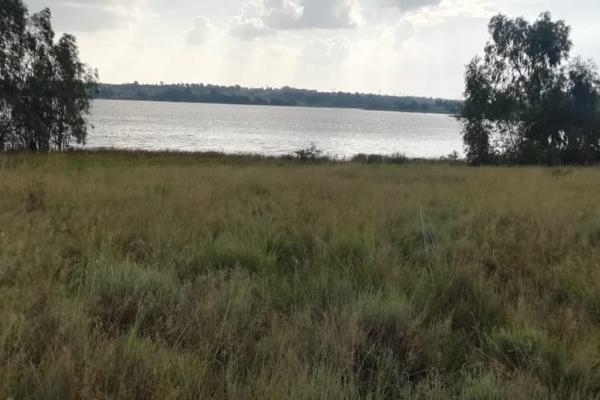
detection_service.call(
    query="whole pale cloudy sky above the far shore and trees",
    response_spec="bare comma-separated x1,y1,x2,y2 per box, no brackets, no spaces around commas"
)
25,0,600,99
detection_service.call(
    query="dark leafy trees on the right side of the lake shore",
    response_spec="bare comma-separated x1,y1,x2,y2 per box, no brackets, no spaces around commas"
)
462,13,600,165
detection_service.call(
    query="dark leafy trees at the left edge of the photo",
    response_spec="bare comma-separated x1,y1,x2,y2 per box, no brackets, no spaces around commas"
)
0,0,96,151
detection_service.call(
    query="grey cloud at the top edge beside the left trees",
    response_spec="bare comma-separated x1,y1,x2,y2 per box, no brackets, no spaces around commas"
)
26,0,144,32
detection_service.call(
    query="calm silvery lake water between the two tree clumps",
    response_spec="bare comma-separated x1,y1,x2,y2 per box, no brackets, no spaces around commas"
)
87,100,462,157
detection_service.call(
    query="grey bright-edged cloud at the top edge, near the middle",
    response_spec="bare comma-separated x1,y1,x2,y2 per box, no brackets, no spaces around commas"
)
230,0,363,37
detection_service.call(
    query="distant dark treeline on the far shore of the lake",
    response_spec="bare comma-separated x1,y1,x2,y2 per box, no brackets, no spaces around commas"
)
96,82,463,114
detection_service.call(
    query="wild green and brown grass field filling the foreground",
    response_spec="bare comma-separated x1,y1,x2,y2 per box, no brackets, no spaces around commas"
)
0,153,600,400
